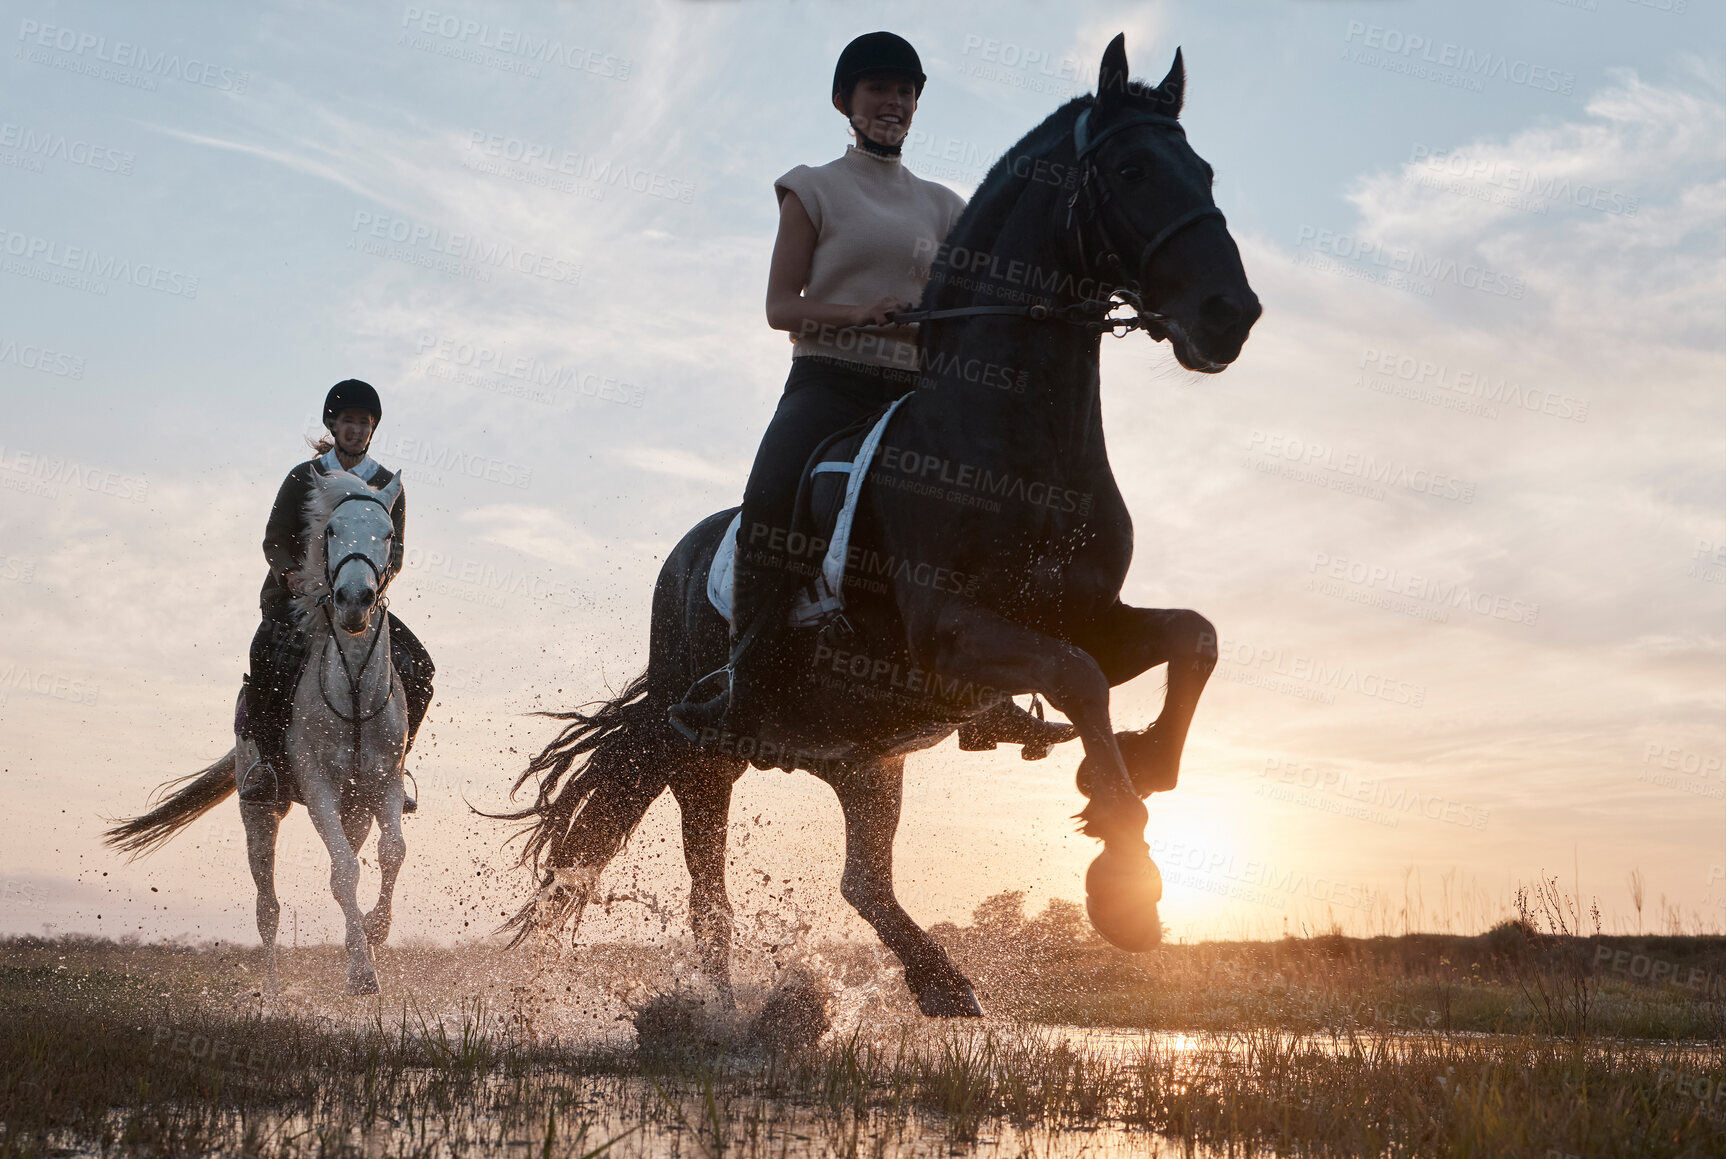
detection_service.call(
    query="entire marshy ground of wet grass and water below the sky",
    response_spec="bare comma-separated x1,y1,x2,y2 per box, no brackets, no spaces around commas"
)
0,898,1726,1159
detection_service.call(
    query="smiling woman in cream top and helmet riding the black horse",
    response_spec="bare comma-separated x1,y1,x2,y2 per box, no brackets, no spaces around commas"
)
670,33,1074,760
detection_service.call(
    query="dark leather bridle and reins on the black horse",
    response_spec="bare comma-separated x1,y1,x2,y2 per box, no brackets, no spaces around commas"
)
892,105,1225,339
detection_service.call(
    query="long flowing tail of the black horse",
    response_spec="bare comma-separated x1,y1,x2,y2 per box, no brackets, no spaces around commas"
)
475,672,675,947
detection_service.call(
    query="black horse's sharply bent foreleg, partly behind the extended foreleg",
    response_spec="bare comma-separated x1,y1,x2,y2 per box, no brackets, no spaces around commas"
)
1075,603,1217,796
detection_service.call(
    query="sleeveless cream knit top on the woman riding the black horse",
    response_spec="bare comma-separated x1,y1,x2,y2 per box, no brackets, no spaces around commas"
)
773,145,965,370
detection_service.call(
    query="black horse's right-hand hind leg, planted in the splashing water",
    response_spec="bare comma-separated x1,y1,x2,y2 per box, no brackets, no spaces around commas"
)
822,757,982,1017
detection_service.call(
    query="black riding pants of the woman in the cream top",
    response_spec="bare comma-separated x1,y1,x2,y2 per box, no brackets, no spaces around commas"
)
734,356,917,634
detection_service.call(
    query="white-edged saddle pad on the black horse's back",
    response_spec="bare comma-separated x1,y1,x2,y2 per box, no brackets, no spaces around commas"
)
708,394,910,627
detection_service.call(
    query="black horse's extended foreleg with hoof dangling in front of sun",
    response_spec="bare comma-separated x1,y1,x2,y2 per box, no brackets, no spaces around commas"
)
930,603,1163,952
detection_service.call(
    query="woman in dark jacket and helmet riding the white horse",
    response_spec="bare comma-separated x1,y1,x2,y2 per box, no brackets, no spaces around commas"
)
236,378,435,814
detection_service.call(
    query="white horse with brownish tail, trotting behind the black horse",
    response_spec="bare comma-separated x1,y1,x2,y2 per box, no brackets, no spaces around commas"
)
107,473,407,995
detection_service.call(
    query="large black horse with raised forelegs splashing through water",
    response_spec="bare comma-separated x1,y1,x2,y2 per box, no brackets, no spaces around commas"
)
506,36,1260,1016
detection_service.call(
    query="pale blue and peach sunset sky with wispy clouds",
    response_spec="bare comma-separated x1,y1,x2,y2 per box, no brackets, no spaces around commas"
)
0,0,1726,941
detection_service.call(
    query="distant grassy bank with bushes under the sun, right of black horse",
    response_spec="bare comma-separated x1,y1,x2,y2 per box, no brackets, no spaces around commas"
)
930,893,1726,1043
